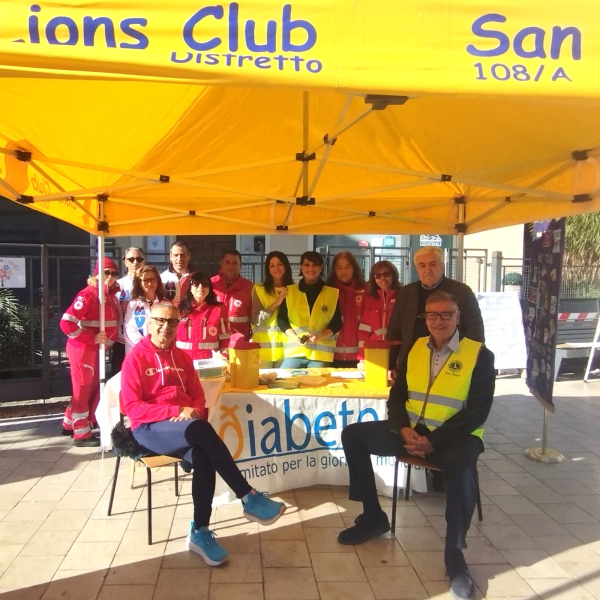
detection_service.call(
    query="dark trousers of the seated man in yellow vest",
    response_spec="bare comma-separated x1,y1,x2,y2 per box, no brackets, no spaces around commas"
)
342,421,483,549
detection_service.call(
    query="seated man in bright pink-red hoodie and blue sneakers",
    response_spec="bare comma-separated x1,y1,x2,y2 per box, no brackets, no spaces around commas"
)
121,302,286,566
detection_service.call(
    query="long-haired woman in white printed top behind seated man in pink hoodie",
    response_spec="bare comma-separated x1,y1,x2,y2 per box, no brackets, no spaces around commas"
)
125,265,166,354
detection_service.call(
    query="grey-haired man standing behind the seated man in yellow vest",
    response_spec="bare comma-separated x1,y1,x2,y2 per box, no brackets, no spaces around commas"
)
386,246,485,371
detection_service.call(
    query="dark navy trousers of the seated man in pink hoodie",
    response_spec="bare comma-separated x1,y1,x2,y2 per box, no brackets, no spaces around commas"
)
133,419,252,528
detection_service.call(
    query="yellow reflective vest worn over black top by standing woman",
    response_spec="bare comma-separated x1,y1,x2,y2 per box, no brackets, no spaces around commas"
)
283,285,339,362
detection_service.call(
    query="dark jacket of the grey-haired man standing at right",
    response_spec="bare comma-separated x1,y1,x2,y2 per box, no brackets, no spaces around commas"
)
386,277,485,369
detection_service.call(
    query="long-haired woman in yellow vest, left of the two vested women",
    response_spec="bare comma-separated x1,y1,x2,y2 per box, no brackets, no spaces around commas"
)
252,250,295,369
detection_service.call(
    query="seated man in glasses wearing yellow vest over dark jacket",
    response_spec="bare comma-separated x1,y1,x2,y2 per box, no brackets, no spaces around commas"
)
338,290,495,600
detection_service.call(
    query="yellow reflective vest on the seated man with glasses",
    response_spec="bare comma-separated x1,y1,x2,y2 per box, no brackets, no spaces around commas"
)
406,337,483,439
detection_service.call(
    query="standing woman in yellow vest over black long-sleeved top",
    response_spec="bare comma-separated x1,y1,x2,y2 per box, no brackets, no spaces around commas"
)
277,251,342,369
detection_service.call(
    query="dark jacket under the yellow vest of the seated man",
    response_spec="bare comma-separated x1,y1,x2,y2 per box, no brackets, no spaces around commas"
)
387,336,496,451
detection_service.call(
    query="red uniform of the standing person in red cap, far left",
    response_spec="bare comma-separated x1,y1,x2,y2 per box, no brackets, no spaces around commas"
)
60,285,119,439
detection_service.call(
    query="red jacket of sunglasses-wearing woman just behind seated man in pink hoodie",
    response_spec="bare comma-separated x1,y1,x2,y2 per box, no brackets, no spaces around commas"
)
175,303,231,360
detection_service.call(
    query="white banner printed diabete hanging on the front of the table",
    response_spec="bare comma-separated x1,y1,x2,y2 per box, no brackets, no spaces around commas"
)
210,392,427,505
